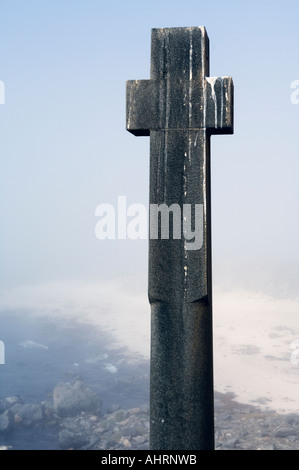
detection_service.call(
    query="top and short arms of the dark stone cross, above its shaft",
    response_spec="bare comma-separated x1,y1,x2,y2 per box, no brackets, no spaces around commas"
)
127,26,233,136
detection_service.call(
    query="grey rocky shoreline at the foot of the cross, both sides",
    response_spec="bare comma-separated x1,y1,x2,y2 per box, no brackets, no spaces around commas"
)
0,379,299,450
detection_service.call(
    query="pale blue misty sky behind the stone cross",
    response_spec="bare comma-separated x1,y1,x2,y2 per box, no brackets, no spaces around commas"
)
0,0,299,295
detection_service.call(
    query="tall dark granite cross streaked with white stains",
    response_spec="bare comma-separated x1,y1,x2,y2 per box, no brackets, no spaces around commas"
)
126,27,233,450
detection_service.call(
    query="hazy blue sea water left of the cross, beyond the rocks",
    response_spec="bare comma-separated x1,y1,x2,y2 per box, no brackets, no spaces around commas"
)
0,311,149,450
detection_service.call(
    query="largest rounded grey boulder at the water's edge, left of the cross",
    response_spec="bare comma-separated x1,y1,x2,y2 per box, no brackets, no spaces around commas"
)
53,380,102,417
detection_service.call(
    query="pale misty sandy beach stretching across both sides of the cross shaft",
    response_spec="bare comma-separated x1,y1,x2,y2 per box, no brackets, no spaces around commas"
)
0,279,299,412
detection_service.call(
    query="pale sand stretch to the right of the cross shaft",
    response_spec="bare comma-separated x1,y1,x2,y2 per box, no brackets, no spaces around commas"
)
214,292,299,412
